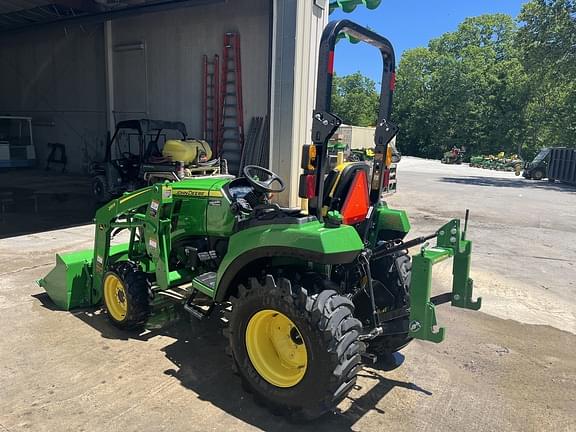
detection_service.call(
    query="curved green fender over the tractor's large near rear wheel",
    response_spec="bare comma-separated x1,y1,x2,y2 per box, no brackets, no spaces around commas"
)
214,221,363,302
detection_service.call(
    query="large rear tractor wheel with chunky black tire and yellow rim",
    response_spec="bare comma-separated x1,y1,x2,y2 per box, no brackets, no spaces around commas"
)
227,275,365,421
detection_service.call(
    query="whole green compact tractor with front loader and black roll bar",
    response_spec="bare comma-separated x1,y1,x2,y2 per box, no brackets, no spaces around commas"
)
39,20,480,420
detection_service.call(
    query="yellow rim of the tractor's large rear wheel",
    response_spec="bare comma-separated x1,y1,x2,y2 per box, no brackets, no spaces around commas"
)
246,309,308,387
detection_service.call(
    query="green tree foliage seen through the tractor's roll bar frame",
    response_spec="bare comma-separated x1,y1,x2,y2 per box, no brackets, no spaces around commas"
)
332,72,379,126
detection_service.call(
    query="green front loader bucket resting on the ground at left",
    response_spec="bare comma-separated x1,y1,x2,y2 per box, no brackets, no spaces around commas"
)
38,249,94,310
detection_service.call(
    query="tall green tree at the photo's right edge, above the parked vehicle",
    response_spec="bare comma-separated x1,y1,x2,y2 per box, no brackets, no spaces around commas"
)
515,0,576,159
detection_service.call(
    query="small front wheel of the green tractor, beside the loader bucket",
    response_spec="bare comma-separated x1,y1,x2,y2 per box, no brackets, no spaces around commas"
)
102,261,151,329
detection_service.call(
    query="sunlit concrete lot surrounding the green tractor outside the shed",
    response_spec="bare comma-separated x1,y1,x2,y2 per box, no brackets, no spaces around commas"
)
0,158,576,432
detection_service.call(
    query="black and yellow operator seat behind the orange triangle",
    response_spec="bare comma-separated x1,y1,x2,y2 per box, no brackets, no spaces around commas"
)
322,162,370,214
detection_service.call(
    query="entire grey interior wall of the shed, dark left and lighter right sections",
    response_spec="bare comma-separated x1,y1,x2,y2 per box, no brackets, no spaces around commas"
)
0,0,270,172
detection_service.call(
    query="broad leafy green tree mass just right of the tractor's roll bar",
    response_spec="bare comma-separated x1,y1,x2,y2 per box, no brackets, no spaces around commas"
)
394,14,526,157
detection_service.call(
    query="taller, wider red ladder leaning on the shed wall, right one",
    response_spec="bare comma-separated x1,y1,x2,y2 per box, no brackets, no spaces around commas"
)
218,33,244,174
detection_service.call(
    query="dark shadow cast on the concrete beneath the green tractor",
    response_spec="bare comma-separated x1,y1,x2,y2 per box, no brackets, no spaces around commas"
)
33,293,432,432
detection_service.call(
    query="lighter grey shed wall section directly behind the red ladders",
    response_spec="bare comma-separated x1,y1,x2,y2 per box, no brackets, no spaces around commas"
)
112,0,270,137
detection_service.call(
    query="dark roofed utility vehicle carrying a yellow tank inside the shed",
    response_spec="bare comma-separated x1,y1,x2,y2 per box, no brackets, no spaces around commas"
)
90,119,220,203
